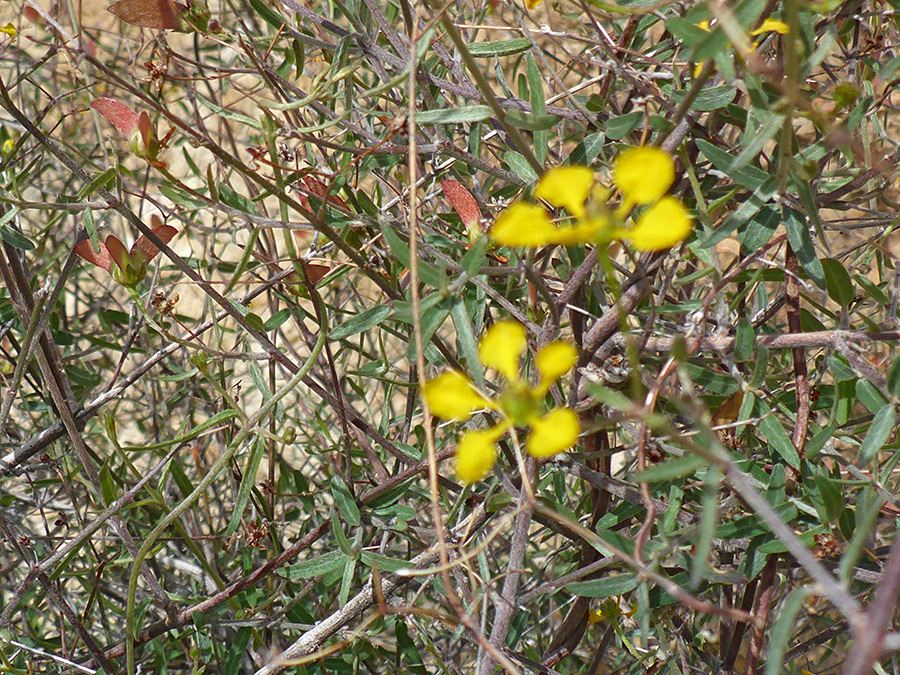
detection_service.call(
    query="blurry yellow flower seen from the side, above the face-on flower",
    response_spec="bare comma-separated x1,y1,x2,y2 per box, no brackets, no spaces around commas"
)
490,147,692,251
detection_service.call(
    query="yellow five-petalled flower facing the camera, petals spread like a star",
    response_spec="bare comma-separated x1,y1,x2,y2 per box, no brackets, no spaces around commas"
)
423,321,581,483
